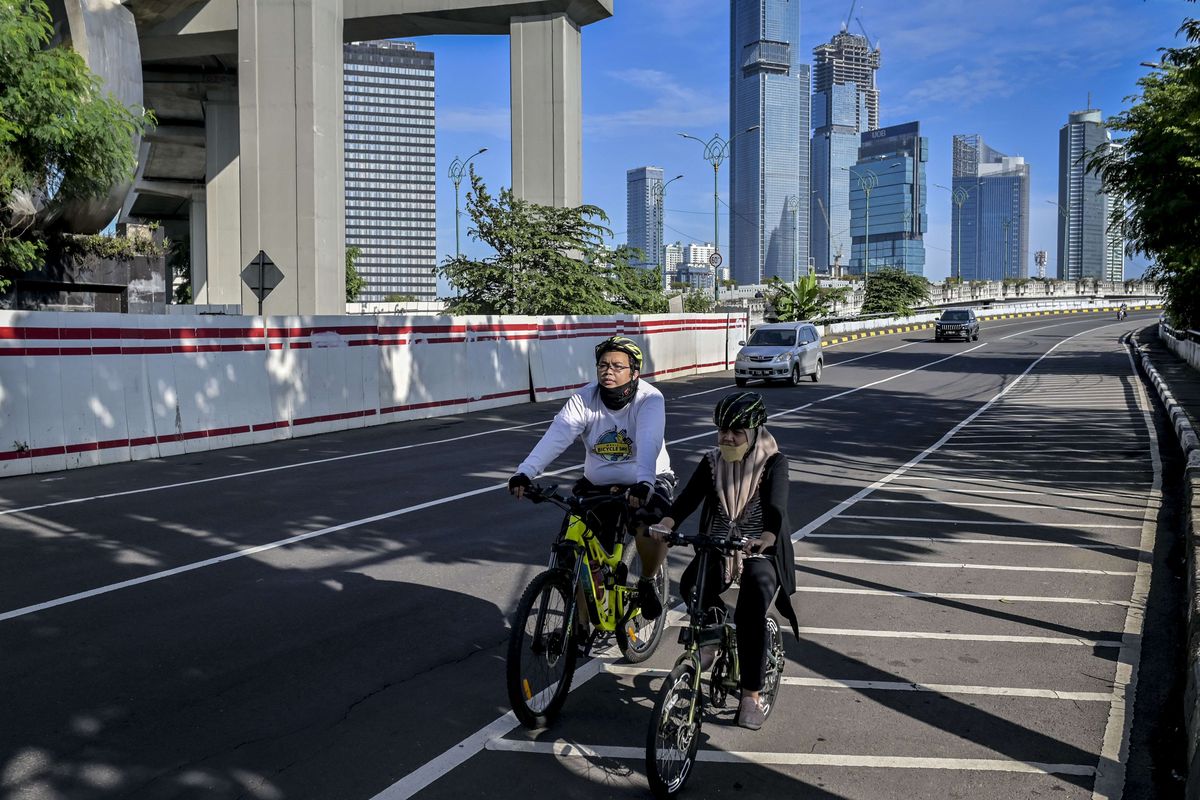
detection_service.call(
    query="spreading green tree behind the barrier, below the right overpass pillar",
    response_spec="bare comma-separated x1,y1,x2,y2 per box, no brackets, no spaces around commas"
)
438,169,666,314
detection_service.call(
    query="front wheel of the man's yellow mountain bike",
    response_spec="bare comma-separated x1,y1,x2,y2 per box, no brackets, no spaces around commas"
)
506,572,577,728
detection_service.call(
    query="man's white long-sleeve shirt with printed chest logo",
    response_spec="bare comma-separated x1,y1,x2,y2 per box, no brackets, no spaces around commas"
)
517,381,671,486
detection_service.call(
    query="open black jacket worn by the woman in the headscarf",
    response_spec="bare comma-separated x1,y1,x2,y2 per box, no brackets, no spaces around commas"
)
666,453,800,638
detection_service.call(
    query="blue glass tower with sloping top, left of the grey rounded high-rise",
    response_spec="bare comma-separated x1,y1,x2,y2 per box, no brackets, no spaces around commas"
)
950,134,1030,281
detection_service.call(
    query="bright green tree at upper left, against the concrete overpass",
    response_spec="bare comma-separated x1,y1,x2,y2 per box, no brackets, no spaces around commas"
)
0,0,154,290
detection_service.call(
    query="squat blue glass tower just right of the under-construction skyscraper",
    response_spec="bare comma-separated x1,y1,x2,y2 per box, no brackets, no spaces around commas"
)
850,122,929,275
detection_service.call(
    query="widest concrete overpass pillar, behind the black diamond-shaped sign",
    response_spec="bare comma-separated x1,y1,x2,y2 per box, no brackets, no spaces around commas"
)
235,0,346,314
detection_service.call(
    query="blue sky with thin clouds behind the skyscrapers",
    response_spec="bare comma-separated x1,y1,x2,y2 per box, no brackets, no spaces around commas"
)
416,0,1185,286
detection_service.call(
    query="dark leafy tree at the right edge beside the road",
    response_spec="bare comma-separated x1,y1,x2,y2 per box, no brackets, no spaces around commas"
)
1087,0,1200,329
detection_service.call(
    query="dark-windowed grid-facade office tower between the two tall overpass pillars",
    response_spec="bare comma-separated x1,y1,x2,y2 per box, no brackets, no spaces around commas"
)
343,42,438,302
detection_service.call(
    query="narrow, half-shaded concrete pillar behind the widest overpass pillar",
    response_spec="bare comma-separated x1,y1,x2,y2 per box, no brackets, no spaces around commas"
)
199,90,241,303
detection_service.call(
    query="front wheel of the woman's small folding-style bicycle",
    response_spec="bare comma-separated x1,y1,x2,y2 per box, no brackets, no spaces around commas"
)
646,661,703,798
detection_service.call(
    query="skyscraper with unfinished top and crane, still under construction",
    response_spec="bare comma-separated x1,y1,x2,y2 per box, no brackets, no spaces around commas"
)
809,30,880,272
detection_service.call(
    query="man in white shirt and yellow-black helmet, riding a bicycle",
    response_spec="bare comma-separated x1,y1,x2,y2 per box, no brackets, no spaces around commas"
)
509,336,676,620
